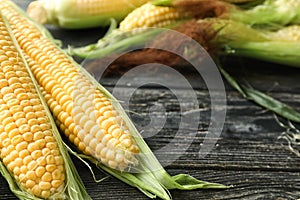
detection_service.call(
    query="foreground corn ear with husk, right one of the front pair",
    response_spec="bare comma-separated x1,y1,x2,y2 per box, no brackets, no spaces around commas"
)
0,1,225,199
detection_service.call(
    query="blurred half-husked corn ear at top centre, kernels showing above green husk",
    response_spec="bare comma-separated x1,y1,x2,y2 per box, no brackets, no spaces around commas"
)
68,2,190,58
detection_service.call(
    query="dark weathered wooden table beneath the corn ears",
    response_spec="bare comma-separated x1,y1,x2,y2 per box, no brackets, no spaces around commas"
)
0,0,300,200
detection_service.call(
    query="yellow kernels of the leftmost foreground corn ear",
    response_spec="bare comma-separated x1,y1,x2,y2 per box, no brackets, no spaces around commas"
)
0,13,65,198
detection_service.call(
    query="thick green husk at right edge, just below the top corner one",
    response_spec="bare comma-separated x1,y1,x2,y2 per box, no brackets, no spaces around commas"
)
202,18,300,67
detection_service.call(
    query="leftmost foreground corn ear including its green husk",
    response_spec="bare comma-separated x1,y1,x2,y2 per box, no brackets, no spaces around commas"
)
0,8,89,200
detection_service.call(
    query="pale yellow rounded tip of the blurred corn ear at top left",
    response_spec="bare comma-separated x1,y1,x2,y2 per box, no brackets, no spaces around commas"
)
27,1,48,24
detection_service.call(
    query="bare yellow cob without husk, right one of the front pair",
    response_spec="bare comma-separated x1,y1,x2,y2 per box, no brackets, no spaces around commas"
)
0,1,139,171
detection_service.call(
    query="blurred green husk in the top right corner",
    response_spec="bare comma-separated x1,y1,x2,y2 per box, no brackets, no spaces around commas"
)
154,0,300,26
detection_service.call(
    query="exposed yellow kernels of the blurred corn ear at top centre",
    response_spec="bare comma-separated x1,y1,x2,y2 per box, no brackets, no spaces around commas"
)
119,3,187,31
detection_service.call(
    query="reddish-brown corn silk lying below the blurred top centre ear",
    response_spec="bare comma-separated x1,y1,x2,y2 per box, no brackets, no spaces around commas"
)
86,19,217,75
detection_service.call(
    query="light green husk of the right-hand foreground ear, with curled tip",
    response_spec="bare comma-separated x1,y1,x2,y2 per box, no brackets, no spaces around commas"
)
7,0,227,199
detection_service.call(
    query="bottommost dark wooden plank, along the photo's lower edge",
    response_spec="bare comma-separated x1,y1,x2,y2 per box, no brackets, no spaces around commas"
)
0,165,300,200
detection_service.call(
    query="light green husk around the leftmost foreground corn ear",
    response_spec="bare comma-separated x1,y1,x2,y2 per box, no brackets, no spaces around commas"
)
0,10,91,200
